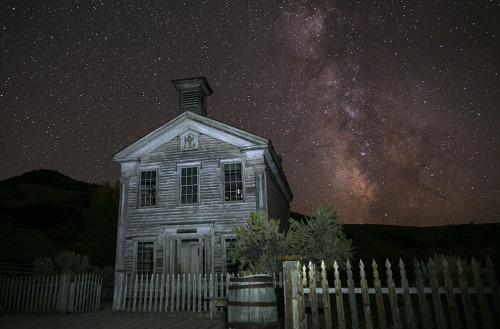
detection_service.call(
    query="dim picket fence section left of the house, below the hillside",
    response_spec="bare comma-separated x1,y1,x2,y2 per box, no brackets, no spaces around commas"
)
0,274,102,313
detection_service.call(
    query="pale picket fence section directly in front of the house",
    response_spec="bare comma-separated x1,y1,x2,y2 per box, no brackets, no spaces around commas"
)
113,273,283,312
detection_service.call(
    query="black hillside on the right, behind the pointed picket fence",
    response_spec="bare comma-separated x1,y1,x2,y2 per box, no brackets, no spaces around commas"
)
343,223,500,275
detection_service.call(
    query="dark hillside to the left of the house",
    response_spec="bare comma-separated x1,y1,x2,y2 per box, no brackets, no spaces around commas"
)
0,170,118,266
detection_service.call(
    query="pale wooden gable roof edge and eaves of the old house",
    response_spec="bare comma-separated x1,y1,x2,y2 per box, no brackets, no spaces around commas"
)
113,111,293,201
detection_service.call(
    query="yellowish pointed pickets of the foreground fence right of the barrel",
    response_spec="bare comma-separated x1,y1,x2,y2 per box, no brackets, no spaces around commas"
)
284,258,500,329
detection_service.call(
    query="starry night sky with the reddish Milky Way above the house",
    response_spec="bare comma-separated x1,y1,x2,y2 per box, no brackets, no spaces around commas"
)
0,0,500,226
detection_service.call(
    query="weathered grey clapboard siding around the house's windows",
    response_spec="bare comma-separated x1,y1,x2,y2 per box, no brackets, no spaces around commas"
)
122,134,276,273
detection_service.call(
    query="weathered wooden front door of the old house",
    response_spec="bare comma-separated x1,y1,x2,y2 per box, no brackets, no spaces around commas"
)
177,239,203,275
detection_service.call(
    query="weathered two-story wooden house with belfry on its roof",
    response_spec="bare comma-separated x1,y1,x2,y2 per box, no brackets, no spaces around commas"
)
114,77,293,280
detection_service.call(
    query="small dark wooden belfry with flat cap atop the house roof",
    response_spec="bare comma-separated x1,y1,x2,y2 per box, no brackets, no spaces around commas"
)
172,77,213,116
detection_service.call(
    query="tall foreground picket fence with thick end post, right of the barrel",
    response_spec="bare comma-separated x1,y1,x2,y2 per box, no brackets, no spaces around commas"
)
284,259,500,329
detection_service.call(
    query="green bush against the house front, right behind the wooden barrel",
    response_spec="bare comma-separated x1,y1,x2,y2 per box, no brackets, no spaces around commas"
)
229,211,286,273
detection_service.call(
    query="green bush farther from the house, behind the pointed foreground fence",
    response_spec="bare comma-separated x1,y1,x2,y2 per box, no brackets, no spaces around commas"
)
287,204,352,268
